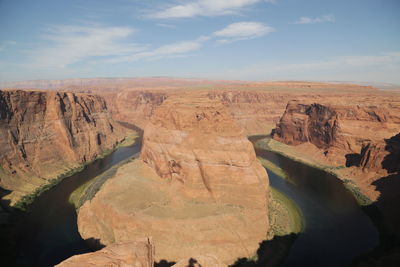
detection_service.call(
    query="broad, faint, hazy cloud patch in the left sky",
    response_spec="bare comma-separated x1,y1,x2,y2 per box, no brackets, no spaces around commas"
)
28,25,144,67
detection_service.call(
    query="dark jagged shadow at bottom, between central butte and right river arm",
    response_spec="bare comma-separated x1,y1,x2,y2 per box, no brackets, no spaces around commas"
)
230,234,298,267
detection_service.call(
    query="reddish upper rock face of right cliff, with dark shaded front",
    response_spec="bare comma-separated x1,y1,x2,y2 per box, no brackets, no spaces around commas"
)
272,101,400,168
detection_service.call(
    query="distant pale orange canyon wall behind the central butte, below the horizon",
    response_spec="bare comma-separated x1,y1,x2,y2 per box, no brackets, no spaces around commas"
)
98,81,379,135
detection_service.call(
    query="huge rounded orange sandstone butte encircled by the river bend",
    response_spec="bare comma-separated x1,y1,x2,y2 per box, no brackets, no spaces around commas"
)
78,97,269,266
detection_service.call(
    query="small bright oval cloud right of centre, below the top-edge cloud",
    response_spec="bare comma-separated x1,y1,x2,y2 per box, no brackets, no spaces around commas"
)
212,21,275,43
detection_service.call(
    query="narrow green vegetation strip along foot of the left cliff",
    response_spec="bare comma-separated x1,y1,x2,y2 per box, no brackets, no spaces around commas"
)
14,132,138,211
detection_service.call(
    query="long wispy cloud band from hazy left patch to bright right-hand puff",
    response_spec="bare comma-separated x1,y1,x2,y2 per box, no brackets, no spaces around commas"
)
26,22,274,69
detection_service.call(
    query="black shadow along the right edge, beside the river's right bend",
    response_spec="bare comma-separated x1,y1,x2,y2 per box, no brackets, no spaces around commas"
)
352,133,400,267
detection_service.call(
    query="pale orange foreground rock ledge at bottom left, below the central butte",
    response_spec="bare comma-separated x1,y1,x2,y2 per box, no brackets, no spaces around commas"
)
56,238,154,267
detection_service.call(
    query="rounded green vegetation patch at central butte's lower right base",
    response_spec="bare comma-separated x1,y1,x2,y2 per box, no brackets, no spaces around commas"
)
268,187,304,236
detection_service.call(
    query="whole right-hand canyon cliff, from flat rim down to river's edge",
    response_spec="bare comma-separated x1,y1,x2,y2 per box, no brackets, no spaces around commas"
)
273,101,400,237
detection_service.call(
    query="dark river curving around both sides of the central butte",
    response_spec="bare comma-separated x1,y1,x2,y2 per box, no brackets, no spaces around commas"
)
8,136,379,267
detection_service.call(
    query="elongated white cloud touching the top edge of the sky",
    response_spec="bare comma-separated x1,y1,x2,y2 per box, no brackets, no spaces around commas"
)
148,0,262,19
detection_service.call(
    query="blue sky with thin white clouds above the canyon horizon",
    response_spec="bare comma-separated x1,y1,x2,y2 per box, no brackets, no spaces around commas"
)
0,0,400,84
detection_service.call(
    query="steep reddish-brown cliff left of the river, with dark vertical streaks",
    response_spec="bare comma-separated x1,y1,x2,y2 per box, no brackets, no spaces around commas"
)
0,90,124,205
